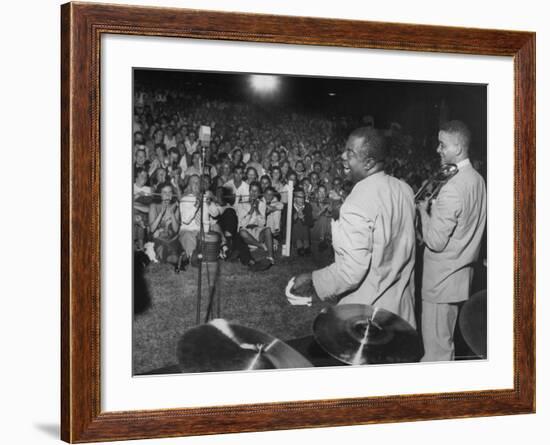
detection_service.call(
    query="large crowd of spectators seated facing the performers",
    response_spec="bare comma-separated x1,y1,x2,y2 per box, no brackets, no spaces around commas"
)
133,87,484,269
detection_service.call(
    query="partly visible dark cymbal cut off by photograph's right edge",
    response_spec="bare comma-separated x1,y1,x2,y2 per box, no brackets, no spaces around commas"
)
458,290,487,358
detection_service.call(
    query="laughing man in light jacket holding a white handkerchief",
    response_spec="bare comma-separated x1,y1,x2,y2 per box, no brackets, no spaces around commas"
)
289,127,416,327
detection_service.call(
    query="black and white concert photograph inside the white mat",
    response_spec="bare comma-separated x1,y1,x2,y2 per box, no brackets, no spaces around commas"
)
132,68,490,376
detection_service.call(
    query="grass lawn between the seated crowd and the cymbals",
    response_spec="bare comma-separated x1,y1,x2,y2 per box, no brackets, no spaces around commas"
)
132,245,331,374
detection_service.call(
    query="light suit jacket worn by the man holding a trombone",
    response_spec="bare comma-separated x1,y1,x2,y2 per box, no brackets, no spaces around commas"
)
422,160,487,303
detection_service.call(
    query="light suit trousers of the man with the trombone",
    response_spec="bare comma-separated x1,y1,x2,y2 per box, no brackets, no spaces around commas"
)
421,300,459,362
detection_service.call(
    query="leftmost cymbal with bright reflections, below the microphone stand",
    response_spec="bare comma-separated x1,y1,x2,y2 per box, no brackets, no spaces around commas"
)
177,318,313,372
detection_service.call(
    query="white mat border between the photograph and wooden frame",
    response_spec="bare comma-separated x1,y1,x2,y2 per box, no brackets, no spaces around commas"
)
101,35,514,411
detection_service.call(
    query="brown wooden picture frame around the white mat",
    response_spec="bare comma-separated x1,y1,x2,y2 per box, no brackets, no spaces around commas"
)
61,3,535,443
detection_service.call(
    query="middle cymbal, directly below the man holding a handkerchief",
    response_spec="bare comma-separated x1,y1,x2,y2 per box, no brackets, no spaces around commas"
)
313,304,422,365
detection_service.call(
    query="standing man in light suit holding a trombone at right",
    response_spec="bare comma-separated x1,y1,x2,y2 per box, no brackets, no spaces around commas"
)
418,121,487,361
